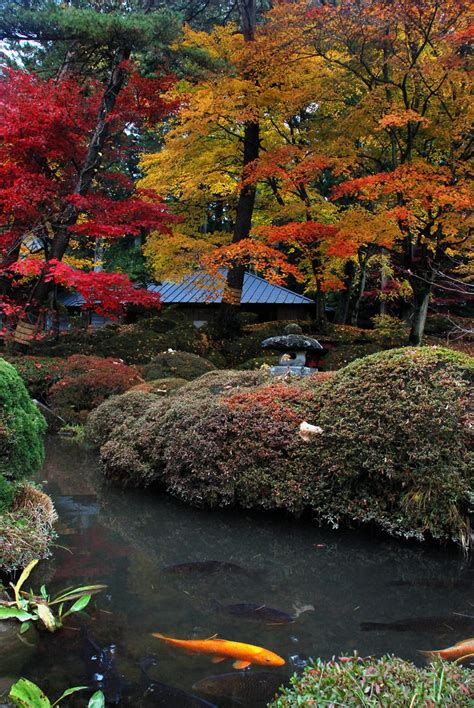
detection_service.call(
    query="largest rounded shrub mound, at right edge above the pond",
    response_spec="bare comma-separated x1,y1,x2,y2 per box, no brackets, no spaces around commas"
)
299,347,473,540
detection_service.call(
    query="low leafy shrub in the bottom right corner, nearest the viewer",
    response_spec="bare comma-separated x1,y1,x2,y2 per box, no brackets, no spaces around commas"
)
270,656,474,708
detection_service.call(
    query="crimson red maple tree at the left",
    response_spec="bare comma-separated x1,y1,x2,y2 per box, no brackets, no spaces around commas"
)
0,62,176,316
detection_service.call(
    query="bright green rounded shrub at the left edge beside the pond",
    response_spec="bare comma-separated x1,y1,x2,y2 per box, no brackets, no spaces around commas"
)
0,359,46,500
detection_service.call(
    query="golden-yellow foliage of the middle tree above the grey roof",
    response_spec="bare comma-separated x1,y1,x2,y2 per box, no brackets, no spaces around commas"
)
141,7,335,302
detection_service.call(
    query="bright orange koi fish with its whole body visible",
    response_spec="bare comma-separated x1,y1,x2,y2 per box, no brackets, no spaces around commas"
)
152,632,285,669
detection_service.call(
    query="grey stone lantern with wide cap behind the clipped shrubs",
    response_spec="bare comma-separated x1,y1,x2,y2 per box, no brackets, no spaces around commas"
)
262,324,323,376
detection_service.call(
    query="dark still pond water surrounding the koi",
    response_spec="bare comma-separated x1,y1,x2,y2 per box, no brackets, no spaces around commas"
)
0,438,474,706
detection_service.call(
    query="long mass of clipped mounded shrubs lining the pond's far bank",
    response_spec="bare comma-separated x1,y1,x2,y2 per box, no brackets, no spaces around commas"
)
101,348,474,544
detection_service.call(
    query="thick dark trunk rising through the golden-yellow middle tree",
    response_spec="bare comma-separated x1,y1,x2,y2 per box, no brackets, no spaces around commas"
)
222,0,260,306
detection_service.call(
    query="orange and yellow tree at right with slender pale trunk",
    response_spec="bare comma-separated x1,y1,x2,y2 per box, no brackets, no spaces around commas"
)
296,0,472,344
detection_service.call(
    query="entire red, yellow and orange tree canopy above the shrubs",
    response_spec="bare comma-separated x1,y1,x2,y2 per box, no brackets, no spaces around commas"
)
0,0,472,344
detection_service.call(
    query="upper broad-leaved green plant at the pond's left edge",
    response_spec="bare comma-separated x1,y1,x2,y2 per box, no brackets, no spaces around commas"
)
0,560,106,634
